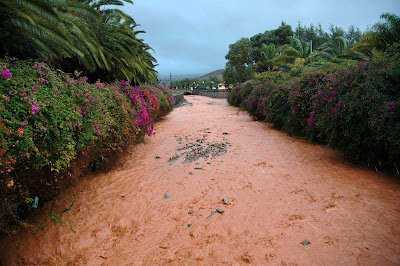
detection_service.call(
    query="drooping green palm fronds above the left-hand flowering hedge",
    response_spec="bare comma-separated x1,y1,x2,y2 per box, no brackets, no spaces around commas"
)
0,0,157,84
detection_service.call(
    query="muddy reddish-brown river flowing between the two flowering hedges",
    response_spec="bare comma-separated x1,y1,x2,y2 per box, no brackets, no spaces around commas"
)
0,96,400,265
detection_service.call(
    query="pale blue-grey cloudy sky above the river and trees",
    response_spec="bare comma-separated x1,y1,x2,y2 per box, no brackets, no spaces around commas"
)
122,0,400,75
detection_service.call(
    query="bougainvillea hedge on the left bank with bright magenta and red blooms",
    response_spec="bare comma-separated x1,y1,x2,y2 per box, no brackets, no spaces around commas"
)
0,58,173,232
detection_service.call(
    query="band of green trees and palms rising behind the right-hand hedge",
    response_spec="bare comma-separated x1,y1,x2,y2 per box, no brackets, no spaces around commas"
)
224,13,400,84
